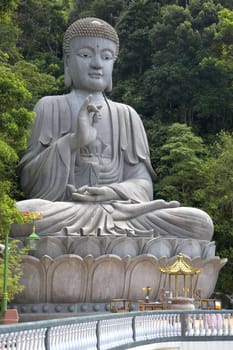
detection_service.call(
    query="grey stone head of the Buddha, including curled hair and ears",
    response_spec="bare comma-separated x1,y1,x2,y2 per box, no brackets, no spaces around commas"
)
63,17,119,92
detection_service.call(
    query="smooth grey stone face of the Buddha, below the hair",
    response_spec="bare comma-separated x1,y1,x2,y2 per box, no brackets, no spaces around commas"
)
66,37,116,92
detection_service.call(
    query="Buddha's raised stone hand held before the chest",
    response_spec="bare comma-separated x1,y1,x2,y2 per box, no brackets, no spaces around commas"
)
71,95,101,150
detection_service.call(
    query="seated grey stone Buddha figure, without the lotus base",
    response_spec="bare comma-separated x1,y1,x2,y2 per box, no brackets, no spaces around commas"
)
12,18,213,241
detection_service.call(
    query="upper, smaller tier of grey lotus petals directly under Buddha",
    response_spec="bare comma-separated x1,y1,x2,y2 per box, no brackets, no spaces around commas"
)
16,235,215,259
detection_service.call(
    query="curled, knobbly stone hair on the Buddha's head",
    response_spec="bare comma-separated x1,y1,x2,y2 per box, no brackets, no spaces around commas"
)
63,17,119,56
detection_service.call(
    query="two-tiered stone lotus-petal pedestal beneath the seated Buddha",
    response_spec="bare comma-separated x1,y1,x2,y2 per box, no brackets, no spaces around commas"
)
14,236,226,311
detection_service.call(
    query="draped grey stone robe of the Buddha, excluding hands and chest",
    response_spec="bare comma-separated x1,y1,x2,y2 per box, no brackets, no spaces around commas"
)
17,91,213,240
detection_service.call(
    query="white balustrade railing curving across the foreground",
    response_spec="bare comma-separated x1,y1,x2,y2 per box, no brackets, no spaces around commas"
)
0,310,233,350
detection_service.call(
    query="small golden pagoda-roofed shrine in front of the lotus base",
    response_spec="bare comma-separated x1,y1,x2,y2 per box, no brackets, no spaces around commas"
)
160,253,201,298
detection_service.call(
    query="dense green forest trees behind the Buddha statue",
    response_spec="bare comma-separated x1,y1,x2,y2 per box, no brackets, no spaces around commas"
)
0,0,233,294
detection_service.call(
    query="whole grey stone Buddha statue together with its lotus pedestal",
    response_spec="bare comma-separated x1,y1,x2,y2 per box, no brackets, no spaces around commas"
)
11,18,226,317
